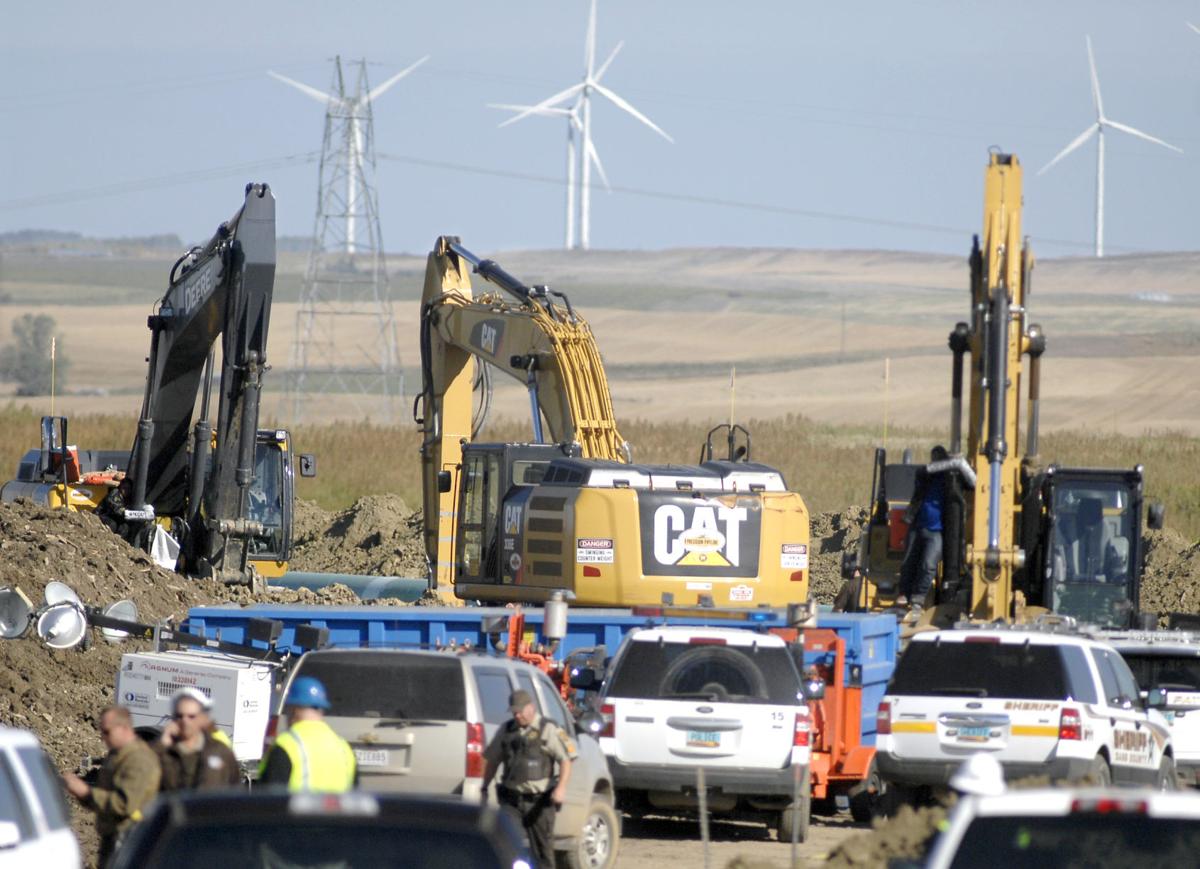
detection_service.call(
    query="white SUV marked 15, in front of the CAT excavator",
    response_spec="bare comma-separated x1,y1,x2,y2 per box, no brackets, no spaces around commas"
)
600,627,811,841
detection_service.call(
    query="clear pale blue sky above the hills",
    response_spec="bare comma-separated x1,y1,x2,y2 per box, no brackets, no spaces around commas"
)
0,0,1200,256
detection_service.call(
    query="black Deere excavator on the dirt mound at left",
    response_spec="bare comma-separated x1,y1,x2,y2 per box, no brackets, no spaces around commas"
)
0,184,314,583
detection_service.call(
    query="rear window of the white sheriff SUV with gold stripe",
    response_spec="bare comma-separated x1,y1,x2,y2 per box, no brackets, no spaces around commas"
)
888,642,1072,700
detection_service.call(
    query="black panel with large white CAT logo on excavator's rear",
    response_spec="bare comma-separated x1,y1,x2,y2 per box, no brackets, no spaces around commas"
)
638,492,762,576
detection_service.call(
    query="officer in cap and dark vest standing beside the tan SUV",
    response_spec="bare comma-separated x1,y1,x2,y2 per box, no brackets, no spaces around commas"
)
484,691,577,869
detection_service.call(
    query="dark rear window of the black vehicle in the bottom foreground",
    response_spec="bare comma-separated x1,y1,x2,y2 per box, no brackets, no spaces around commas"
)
150,817,500,869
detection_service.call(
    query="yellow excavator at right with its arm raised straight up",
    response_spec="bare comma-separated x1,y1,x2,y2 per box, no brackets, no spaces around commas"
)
840,151,1163,627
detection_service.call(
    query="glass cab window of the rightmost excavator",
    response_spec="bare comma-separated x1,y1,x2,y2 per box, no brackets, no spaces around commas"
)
1048,480,1136,625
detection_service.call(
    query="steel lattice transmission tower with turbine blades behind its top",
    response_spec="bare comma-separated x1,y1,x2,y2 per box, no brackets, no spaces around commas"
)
270,56,428,422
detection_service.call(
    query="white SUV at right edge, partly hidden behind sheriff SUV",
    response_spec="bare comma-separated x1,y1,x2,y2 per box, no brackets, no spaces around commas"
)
1103,630,1200,786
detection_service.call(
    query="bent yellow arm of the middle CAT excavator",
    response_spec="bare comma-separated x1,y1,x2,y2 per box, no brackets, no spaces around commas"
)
415,236,629,588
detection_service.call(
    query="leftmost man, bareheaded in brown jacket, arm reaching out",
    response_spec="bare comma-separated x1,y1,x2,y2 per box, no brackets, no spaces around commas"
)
62,706,162,869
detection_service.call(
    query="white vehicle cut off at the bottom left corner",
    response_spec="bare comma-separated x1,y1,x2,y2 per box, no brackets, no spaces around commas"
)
0,727,82,869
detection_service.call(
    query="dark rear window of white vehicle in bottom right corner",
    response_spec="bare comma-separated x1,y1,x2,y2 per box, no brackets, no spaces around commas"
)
950,813,1200,869
